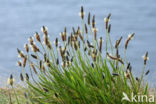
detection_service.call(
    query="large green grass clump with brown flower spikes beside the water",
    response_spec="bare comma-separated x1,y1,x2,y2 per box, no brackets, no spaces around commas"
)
7,7,155,104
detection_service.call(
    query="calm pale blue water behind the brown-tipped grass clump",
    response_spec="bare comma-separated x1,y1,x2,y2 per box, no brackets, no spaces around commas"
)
0,0,156,86
